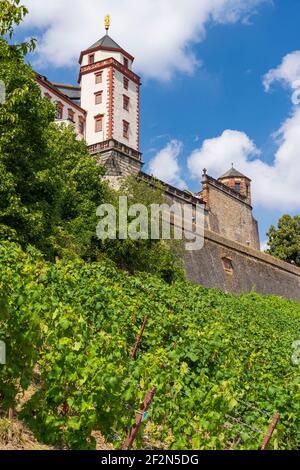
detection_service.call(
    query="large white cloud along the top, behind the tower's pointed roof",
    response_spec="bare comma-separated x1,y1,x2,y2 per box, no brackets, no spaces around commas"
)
22,0,271,80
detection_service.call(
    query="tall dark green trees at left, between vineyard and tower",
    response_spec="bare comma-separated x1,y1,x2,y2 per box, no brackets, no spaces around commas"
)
0,0,109,259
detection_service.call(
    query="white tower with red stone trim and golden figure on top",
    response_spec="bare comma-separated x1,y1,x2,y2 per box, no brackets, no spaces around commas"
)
79,17,142,176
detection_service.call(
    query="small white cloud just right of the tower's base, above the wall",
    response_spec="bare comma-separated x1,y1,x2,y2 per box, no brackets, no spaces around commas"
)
148,140,186,189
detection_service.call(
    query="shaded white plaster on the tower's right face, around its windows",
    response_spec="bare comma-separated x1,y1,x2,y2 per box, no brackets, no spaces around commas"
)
114,70,138,150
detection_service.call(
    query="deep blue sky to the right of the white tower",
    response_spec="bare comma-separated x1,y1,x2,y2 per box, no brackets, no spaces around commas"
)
141,0,300,240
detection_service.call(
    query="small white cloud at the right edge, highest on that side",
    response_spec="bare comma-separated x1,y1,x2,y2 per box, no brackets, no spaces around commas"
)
263,51,300,91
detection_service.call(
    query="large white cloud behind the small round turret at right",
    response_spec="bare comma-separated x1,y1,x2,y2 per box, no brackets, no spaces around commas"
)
188,108,300,211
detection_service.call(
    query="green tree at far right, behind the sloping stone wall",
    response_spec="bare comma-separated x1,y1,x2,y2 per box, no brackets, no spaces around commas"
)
267,215,300,267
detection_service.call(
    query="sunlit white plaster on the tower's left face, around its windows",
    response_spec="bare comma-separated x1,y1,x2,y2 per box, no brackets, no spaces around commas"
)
81,68,109,145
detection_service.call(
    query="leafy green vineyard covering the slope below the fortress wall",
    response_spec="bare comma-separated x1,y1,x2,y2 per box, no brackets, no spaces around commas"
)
0,242,300,449
